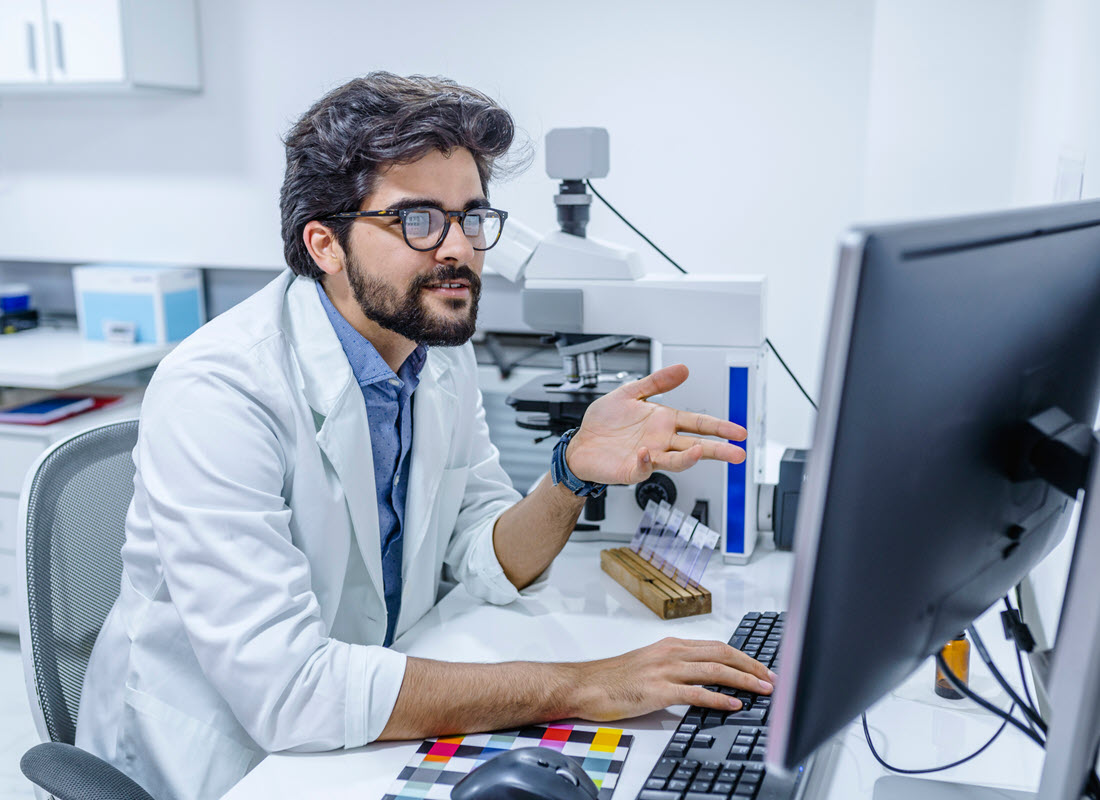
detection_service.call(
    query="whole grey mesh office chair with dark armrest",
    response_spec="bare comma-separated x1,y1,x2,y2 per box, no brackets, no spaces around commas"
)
17,419,153,800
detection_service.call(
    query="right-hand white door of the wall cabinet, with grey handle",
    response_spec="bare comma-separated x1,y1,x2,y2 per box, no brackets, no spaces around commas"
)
45,0,125,84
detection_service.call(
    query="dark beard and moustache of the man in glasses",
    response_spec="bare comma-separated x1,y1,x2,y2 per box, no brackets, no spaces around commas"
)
347,252,481,347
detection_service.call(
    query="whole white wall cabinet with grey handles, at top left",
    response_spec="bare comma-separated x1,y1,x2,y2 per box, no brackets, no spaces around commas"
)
0,0,200,94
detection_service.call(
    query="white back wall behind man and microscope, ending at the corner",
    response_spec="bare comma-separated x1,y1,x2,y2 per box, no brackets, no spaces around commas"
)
0,0,872,445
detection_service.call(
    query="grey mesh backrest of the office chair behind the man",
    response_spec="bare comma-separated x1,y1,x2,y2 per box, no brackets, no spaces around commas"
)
23,419,138,744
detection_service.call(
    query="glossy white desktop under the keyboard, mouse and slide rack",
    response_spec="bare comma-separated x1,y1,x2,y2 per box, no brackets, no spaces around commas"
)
226,543,1041,800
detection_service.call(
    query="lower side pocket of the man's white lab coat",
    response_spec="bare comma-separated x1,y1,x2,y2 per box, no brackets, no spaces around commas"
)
117,687,264,800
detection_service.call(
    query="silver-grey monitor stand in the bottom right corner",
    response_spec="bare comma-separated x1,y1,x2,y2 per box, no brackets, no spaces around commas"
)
873,431,1100,800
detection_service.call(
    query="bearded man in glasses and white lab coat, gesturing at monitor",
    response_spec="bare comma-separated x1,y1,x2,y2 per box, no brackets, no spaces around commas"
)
77,73,773,800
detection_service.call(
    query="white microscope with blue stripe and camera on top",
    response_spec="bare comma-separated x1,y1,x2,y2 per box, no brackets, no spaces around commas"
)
490,128,770,562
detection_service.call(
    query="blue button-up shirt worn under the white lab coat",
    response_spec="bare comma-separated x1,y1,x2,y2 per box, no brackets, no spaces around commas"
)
317,282,428,647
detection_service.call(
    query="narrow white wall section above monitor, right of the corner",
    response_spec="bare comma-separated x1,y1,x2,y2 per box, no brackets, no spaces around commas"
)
861,0,1049,221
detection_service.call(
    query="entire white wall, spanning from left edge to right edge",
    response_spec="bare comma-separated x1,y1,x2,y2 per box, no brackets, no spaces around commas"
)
0,0,1100,446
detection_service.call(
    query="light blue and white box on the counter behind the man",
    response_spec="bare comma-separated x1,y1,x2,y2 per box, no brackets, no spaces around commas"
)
73,264,206,344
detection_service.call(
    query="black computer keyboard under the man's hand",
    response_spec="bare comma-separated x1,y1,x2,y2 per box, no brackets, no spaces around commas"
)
638,612,802,800
